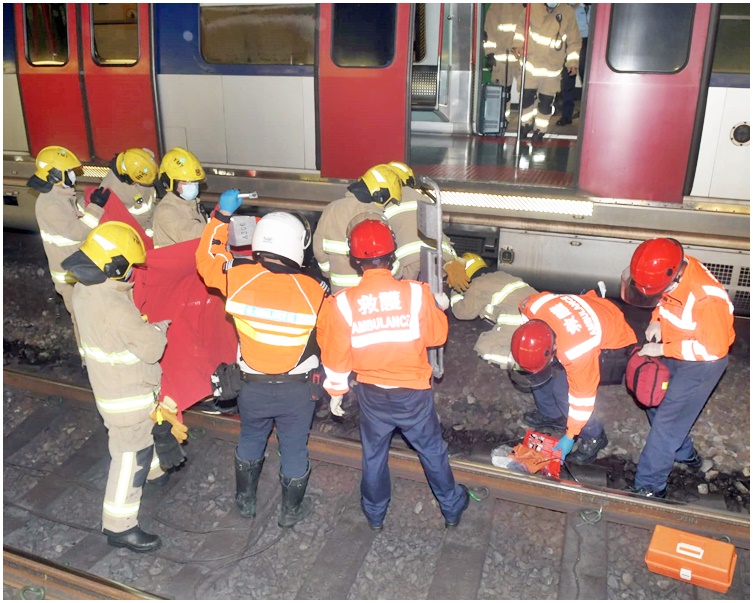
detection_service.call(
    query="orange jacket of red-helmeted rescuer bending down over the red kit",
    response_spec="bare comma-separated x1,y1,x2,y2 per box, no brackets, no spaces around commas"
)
520,291,637,437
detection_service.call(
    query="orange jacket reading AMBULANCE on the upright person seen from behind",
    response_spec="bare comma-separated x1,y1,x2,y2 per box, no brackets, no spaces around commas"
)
317,269,448,395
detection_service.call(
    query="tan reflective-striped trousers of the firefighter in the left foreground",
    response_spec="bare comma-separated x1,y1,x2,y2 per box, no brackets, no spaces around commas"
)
97,407,164,532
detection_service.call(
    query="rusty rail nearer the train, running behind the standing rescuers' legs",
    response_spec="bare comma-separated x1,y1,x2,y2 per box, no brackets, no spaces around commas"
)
3,369,750,549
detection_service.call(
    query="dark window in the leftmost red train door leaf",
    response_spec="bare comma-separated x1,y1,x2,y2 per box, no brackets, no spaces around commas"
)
24,4,68,66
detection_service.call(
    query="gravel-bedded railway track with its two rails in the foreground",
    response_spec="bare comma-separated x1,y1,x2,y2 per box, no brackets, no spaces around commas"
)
3,370,749,599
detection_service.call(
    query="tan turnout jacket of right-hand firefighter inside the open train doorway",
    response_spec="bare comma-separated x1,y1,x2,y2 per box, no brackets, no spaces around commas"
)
512,3,582,96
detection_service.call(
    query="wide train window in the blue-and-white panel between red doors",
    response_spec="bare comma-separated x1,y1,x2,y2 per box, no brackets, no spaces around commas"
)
200,4,316,65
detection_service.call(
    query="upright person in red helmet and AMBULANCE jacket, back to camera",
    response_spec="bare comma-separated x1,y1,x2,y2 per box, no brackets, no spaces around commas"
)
317,217,469,531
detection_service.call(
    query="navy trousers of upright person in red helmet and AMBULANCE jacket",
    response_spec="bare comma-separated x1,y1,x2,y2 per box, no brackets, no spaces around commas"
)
357,383,466,525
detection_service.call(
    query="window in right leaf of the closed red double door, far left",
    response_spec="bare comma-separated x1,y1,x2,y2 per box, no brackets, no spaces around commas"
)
92,3,139,66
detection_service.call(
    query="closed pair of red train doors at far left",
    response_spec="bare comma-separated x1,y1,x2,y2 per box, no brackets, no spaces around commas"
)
15,3,158,161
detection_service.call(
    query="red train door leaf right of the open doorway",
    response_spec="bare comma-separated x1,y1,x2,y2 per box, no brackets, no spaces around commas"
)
578,3,711,202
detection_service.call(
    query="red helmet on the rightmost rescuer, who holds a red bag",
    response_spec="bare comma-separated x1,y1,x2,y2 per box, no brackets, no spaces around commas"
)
620,239,684,307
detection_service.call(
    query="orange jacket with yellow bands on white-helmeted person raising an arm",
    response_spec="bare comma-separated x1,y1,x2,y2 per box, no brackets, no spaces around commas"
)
196,213,324,375
